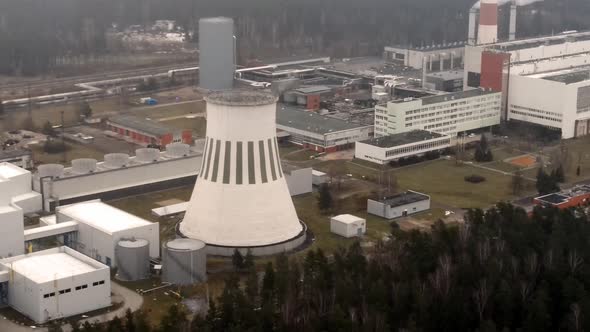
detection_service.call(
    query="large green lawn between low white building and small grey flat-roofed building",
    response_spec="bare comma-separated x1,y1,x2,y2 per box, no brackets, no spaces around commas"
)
394,160,514,208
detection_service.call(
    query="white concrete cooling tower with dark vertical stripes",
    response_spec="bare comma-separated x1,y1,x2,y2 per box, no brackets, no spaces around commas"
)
180,91,305,256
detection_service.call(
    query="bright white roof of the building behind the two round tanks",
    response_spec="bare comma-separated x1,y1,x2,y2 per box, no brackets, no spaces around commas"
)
57,201,153,234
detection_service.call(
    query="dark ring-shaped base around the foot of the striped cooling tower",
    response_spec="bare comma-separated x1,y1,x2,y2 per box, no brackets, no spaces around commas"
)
176,221,309,257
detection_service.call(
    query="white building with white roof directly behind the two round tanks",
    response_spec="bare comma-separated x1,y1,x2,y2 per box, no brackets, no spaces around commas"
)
56,200,160,267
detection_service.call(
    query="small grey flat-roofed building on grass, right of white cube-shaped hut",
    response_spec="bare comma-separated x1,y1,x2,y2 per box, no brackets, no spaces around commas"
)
367,190,430,219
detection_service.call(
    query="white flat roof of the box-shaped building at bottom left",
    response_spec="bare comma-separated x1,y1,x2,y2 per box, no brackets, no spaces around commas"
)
4,252,97,284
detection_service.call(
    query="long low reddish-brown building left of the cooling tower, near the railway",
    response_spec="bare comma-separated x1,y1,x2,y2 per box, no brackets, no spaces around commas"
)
106,115,193,146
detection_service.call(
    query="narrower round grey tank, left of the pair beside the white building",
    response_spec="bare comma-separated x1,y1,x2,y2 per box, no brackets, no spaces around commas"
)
115,239,150,281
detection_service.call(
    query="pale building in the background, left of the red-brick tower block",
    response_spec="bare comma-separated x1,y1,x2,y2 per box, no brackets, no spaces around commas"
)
383,42,465,71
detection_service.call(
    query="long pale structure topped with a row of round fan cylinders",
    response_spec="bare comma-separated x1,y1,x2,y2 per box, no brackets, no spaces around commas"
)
33,142,202,211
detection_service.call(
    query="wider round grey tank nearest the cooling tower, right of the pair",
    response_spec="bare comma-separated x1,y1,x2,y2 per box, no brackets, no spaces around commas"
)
162,239,207,285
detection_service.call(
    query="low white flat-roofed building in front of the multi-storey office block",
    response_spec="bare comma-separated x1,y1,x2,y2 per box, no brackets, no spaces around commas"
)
354,134,452,165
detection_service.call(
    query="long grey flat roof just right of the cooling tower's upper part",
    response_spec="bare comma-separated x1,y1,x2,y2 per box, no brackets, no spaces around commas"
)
277,104,367,135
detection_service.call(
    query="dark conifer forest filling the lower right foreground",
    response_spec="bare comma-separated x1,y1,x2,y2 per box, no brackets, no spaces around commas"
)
70,203,590,332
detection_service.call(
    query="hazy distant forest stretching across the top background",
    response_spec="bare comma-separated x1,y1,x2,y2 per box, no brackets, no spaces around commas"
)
0,0,590,75
